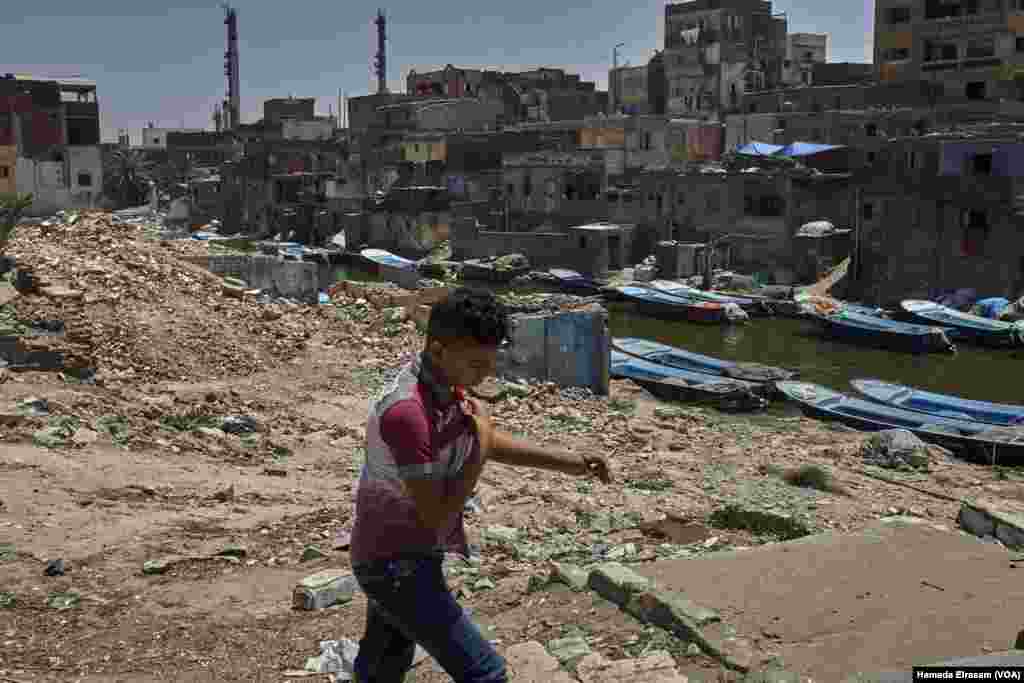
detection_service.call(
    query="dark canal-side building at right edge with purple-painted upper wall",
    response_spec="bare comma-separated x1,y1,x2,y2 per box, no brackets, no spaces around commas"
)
853,125,1024,302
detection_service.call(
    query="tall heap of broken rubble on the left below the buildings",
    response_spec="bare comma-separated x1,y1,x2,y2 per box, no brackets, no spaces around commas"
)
7,212,324,382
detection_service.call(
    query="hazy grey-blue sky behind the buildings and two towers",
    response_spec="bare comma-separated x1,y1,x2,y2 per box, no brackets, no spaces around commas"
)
0,0,873,141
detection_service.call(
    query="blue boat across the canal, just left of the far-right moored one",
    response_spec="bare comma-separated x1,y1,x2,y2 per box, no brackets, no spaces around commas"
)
811,309,955,353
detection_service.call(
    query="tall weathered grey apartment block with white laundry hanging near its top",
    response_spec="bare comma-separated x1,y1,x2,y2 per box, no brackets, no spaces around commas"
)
665,0,786,115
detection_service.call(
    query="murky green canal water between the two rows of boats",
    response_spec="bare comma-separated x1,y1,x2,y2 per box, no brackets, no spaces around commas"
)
335,265,1024,403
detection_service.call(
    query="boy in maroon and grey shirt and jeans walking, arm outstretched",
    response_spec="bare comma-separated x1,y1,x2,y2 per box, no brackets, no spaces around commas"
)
351,288,610,683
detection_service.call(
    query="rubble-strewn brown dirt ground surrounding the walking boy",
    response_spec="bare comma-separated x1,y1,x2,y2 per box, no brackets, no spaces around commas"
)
0,210,1024,683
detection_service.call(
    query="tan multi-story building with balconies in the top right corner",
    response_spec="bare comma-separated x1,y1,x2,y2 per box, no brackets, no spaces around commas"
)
874,0,1024,100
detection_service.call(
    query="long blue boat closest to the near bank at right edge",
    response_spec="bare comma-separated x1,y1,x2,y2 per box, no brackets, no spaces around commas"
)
776,381,1024,462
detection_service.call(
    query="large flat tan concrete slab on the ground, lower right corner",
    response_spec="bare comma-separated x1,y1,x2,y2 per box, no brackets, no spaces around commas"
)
636,517,1024,680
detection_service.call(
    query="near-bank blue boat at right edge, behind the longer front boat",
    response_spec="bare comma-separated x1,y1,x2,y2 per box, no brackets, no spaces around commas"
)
850,379,1024,425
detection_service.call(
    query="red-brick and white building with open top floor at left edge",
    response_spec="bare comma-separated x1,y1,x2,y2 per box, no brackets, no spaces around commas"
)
0,74,103,213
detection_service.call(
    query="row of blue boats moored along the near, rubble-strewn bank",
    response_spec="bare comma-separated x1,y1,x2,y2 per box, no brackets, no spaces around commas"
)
609,337,1024,463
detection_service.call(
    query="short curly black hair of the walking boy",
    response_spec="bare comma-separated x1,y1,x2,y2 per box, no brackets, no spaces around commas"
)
427,287,509,346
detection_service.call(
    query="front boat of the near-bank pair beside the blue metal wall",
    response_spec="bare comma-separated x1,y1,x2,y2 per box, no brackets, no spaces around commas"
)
608,349,767,411
